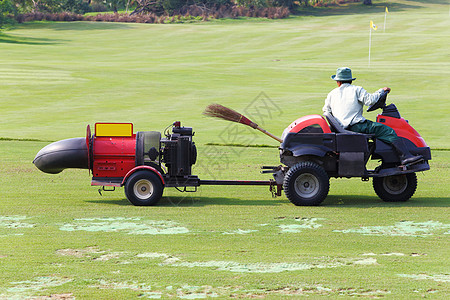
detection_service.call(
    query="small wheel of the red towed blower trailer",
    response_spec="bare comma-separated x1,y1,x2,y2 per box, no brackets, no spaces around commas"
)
125,171,164,206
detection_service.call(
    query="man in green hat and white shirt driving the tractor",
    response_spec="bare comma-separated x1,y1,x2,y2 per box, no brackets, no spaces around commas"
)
323,67,423,165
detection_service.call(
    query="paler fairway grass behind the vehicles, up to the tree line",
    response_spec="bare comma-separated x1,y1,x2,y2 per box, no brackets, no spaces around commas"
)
0,1,450,148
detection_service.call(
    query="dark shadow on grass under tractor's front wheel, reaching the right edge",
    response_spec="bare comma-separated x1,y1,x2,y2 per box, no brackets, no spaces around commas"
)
322,195,450,208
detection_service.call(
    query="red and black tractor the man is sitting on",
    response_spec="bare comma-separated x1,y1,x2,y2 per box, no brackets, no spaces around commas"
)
278,93,431,205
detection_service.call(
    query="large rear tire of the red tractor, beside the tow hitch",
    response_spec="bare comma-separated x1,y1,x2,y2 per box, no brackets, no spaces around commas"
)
283,161,330,206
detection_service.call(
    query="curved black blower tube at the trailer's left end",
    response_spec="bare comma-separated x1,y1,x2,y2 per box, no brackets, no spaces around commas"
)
33,138,89,174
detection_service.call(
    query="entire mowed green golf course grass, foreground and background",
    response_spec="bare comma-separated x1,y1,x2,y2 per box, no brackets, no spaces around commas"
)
0,1,450,299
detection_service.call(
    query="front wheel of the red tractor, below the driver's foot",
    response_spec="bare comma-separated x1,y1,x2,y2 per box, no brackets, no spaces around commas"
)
373,173,417,202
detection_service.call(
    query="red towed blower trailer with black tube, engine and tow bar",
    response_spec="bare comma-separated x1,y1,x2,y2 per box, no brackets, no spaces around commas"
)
33,121,282,206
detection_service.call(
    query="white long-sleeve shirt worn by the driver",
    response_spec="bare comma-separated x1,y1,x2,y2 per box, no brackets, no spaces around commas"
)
322,83,383,128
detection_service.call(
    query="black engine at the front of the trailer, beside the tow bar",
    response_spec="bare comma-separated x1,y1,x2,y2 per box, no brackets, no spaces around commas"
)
160,121,197,176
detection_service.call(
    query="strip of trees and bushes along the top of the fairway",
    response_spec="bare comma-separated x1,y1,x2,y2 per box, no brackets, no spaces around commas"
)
0,0,372,27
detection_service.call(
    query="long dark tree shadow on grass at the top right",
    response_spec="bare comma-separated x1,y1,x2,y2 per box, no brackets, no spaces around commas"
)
294,1,422,17
